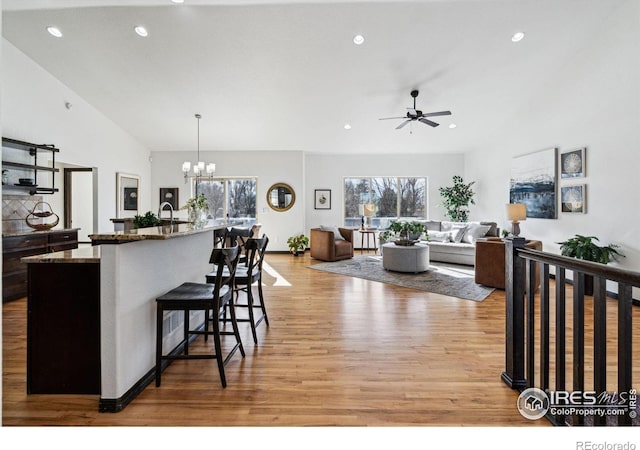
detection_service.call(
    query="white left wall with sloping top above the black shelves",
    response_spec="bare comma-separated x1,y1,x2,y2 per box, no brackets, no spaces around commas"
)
1,39,151,232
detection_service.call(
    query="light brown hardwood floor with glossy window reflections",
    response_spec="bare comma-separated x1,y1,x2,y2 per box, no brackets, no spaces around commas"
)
2,253,632,427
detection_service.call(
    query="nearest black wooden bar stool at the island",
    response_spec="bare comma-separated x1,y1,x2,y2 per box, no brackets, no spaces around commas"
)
155,246,245,387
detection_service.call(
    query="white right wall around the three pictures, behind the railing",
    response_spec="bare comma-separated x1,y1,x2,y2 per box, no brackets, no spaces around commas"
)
465,0,640,278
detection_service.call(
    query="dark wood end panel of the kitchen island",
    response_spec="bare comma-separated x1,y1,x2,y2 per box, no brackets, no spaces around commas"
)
27,262,100,394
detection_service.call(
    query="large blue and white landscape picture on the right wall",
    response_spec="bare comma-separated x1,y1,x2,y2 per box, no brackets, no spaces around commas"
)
509,148,558,219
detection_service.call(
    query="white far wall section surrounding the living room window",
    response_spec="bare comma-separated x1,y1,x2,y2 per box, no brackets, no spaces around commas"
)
305,154,464,232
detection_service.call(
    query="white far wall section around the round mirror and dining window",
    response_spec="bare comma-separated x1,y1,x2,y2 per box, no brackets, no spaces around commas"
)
151,149,307,251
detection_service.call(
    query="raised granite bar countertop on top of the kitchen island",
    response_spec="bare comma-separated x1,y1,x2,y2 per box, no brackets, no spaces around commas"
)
89,223,231,244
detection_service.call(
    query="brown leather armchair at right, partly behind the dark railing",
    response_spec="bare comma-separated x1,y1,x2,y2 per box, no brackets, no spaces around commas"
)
475,238,542,289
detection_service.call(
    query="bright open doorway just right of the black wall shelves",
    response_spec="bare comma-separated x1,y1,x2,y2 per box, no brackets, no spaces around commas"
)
64,165,98,244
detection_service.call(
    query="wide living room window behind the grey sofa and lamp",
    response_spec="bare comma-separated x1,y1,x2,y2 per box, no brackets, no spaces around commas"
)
344,177,427,228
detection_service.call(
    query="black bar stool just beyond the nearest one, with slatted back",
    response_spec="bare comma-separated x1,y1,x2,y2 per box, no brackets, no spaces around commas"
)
206,235,269,344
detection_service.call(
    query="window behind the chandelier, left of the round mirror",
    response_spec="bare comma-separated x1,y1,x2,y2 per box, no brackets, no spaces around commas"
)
192,178,257,226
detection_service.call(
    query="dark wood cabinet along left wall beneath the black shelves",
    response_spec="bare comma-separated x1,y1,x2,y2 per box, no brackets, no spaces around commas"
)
2,230,78,303
